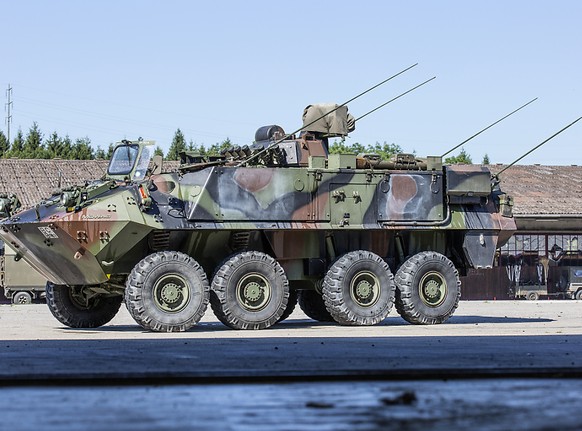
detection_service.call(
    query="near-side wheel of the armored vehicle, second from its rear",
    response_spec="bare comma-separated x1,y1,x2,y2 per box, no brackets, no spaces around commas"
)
322,250,395,326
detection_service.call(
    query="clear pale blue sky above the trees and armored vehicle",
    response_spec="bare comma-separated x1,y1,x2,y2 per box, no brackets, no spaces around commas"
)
0,0,582,165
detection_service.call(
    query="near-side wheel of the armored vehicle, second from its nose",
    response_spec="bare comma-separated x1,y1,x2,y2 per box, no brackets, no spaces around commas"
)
210,251,289,329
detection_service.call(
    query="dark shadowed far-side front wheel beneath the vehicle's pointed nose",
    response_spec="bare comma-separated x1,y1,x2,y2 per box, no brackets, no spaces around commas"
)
45,281,123,328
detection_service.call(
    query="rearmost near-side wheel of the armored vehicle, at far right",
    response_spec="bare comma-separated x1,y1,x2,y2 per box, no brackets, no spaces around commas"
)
396,251,461,325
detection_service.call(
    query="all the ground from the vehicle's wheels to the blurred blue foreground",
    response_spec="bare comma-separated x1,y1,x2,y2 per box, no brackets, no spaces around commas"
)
0,301,582,431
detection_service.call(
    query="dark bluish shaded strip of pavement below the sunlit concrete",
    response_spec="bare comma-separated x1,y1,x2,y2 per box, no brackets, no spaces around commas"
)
0,331,582,384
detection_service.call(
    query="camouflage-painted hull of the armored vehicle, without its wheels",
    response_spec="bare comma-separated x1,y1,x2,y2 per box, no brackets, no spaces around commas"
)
0,137,516,289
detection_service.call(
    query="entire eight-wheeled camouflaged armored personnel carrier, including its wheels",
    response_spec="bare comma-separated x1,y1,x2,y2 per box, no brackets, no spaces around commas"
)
0,105,515,331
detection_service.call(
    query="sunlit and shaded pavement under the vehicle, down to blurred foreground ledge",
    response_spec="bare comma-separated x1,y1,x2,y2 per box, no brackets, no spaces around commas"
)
0,301,582,384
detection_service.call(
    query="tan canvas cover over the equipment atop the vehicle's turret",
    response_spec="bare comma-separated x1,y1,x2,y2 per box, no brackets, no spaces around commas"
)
303,103,356,136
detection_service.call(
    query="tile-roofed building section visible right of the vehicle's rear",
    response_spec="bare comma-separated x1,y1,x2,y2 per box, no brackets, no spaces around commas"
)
463,165,582,299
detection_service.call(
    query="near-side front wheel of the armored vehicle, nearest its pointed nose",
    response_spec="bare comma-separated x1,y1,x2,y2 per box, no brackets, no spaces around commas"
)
125,251,210,332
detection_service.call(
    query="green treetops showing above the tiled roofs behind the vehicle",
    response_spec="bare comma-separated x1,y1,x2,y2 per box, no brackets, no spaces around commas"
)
0,122,489,164
